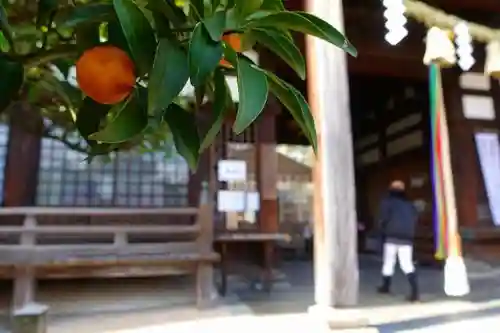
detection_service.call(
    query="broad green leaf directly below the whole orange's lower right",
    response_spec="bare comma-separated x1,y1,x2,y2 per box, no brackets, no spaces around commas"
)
89,91,148,143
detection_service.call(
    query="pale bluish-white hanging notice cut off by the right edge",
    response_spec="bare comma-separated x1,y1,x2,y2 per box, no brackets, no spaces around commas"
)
475,133,500,226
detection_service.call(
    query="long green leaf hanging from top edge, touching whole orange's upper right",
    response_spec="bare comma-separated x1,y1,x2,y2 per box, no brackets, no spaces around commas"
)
113,0,156,75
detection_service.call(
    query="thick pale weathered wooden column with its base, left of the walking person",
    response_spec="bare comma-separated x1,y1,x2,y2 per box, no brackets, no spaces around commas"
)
306,0,367,328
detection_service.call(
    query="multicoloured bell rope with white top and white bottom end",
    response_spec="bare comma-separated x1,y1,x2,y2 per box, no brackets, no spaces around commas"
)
424,27,470,296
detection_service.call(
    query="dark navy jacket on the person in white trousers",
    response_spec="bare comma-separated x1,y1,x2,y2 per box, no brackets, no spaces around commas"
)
378,190,418,242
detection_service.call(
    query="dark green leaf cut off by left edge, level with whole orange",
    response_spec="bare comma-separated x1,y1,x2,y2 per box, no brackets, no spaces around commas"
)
0,54,24,112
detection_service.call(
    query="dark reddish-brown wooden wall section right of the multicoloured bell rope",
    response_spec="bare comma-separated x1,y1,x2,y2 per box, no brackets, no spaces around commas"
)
443,71,500,261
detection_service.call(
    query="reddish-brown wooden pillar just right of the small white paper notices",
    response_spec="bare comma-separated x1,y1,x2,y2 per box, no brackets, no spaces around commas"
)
255,107,279,290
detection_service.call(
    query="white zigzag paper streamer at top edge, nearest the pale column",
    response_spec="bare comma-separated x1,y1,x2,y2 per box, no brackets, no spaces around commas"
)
383,0,408,45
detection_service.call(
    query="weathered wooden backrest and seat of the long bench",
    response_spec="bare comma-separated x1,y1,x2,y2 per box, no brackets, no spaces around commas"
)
0,205,213,265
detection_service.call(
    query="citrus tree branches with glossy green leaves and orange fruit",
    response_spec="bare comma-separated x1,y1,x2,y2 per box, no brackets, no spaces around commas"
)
0,0,356,169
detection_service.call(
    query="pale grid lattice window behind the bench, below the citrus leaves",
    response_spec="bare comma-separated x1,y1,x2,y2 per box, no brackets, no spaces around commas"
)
37,134,189,207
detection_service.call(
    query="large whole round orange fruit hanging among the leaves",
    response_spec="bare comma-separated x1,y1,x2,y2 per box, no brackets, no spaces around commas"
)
76,45,136,104
